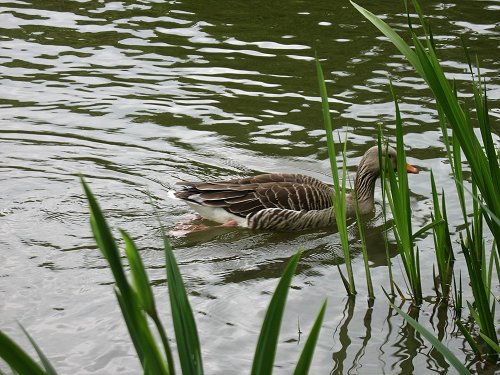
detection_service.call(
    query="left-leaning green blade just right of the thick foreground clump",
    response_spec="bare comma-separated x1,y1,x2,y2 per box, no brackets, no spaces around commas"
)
161,226,203,375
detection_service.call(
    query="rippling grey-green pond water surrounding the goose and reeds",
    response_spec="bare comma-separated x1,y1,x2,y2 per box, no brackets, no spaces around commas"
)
0,0,500,374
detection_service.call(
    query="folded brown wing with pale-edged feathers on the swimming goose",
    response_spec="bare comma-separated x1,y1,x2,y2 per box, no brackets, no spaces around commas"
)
175,173,332,217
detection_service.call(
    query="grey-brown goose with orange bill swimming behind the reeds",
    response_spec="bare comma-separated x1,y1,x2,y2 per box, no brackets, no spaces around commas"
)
174,146,418,231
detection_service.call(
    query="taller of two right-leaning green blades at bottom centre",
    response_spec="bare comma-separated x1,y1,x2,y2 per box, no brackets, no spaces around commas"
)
251,251,301,375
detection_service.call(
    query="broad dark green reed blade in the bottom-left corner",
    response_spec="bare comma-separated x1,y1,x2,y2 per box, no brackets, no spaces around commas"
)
0,331,49,375
